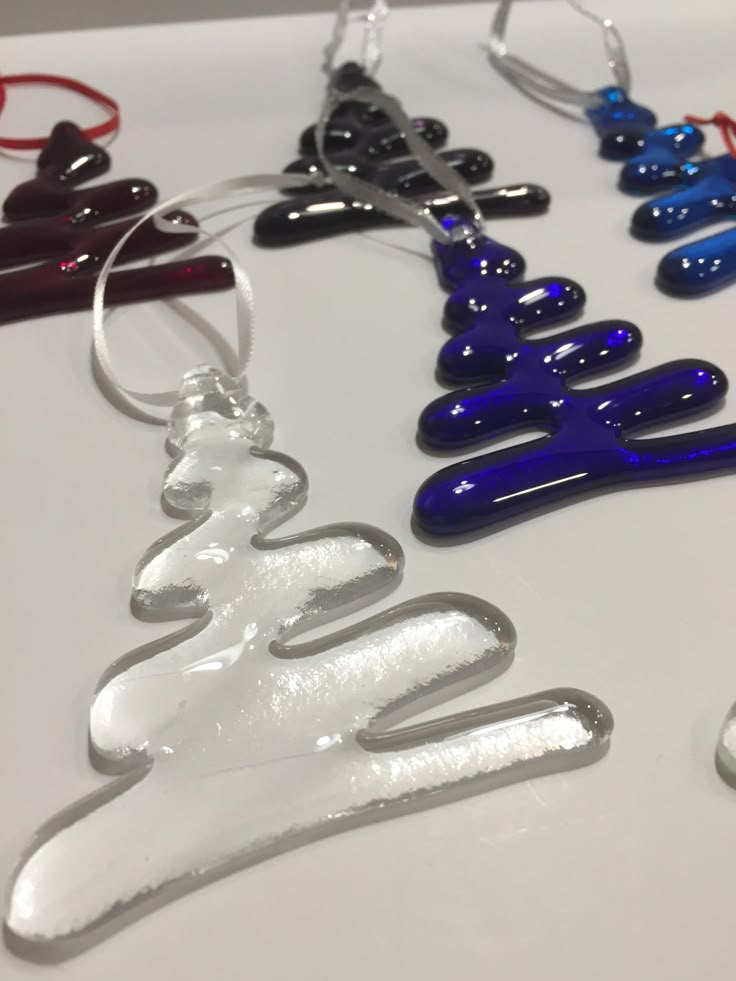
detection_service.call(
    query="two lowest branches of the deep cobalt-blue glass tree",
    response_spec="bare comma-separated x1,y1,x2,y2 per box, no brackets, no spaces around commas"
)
414,356,736,535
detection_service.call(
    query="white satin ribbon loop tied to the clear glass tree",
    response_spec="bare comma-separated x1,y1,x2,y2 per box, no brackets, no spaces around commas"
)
92,174,325,425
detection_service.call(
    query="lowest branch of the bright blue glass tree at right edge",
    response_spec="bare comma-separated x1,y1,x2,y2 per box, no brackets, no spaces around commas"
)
657,228,736,296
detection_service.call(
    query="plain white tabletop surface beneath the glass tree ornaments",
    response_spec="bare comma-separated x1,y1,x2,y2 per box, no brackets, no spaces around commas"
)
0,0,736,981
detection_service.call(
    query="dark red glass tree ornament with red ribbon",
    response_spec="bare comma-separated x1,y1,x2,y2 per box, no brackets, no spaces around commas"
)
0,122,233,323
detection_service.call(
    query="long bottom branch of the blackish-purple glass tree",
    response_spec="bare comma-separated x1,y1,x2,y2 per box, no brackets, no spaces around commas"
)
253,184,549,246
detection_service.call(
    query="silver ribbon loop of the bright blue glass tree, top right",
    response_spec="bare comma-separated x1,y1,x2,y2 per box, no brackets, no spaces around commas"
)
488,0,631,108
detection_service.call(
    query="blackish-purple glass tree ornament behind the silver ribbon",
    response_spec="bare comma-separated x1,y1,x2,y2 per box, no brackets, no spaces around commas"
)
253,62,549,246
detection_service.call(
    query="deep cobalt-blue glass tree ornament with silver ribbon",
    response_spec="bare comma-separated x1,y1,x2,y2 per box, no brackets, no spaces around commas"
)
414,219,736,535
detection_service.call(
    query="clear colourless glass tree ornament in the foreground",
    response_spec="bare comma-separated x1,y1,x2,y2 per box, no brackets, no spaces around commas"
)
6,367,612,958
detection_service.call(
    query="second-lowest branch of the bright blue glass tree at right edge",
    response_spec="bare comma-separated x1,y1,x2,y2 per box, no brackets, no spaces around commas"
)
631,154,736,239
